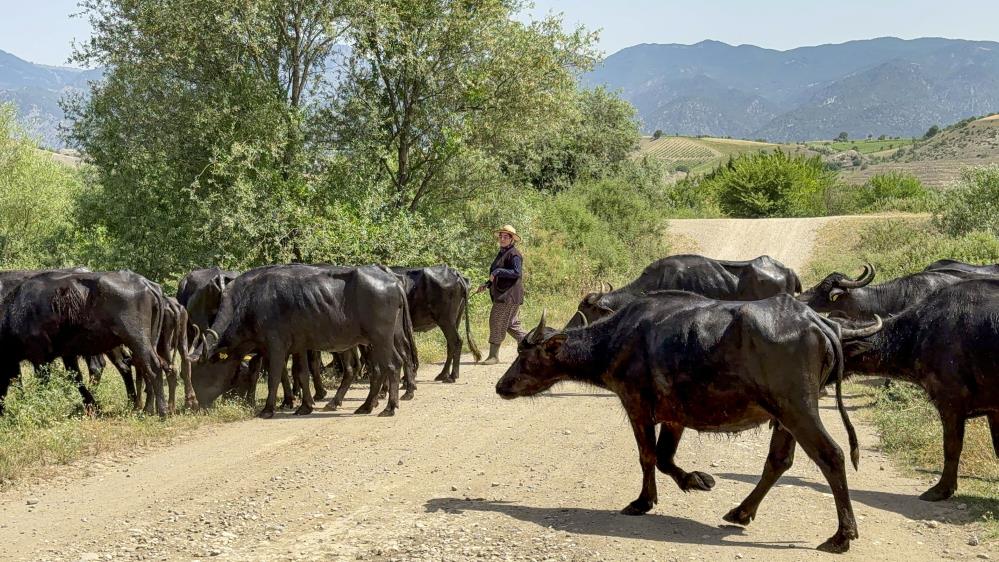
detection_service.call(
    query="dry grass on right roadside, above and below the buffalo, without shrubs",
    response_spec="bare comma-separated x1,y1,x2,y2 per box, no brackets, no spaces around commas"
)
802,215,999,539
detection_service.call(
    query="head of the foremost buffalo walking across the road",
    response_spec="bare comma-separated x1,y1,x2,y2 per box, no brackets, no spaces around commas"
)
496,312,569,400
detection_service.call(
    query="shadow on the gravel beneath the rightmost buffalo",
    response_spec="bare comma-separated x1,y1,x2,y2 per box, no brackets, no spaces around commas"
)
717,472,999,525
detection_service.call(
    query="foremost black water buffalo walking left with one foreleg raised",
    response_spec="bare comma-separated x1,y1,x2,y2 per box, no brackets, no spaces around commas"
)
496,291,878,552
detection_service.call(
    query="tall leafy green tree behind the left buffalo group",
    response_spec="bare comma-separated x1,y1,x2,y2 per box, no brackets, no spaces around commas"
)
66,0,352,278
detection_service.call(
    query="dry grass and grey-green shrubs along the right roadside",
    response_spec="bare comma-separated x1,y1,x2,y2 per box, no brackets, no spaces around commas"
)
803,166,999,537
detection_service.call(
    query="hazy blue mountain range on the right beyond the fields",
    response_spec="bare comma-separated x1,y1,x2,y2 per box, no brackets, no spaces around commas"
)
583,37,999,141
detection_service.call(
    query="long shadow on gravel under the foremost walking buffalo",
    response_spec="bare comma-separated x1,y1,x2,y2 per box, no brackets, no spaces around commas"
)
425,498,808,550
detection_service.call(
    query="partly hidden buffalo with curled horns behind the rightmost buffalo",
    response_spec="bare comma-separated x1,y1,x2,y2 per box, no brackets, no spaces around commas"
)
798,264,961,319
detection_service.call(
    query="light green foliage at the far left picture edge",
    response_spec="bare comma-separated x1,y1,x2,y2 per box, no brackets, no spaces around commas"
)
0,104,79,269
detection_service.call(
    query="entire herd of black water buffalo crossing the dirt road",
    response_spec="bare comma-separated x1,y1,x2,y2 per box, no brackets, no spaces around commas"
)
0,255,999,552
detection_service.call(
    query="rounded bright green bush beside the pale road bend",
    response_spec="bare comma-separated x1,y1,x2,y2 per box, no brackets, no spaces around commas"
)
701,150,836,218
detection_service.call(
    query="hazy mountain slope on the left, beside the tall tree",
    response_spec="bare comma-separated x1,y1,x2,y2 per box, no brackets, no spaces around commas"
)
0,51,101,148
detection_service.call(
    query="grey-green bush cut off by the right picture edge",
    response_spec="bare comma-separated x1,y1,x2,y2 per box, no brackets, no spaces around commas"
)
934,164,999,236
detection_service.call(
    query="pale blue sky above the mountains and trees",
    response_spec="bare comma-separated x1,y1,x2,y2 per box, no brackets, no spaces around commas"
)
0,0,999,66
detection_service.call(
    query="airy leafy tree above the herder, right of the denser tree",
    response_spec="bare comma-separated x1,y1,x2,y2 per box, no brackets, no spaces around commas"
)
333,0,594,210
